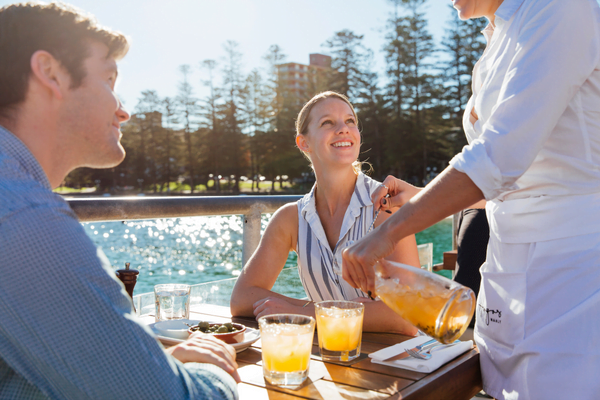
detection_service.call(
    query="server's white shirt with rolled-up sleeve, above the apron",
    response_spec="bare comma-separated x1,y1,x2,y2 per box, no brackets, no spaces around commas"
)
450,0,600,243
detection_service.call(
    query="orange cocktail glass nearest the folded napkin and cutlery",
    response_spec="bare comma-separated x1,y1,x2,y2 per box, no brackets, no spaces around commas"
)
315,300,365,361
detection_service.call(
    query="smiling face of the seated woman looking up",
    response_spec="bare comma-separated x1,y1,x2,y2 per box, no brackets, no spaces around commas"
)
296,97,360,167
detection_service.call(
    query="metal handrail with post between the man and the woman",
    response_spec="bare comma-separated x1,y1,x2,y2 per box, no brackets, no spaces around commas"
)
67,196,302,266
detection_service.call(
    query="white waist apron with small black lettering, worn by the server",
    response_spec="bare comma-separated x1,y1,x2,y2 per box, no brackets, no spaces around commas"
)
475,230,600,400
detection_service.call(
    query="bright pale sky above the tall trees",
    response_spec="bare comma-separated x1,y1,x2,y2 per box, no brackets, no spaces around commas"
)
0,0,451,111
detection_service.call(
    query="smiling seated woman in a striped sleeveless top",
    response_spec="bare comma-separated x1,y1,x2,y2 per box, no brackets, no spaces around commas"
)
231,92,420,335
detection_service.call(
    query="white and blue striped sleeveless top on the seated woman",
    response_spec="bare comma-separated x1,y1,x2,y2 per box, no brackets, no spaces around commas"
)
296,173,382,301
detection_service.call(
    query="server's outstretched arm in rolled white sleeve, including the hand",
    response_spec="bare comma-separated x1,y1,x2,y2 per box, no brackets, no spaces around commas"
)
343,0,600,290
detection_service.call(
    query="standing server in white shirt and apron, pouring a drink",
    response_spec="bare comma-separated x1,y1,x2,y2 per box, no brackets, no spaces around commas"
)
343,0,600,399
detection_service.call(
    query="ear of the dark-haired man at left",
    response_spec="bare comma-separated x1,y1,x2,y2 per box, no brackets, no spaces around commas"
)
31,50,71,99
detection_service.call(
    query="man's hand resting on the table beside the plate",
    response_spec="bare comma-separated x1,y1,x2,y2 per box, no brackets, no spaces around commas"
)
165,332,241,383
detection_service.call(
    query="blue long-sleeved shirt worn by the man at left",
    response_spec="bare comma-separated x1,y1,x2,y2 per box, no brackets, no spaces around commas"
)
0,126,237,399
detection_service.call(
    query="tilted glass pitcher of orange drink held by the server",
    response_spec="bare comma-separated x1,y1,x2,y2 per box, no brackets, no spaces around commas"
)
375,260,475,343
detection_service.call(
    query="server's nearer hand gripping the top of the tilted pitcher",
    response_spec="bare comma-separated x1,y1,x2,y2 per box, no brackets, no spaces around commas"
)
342,225,396,293
